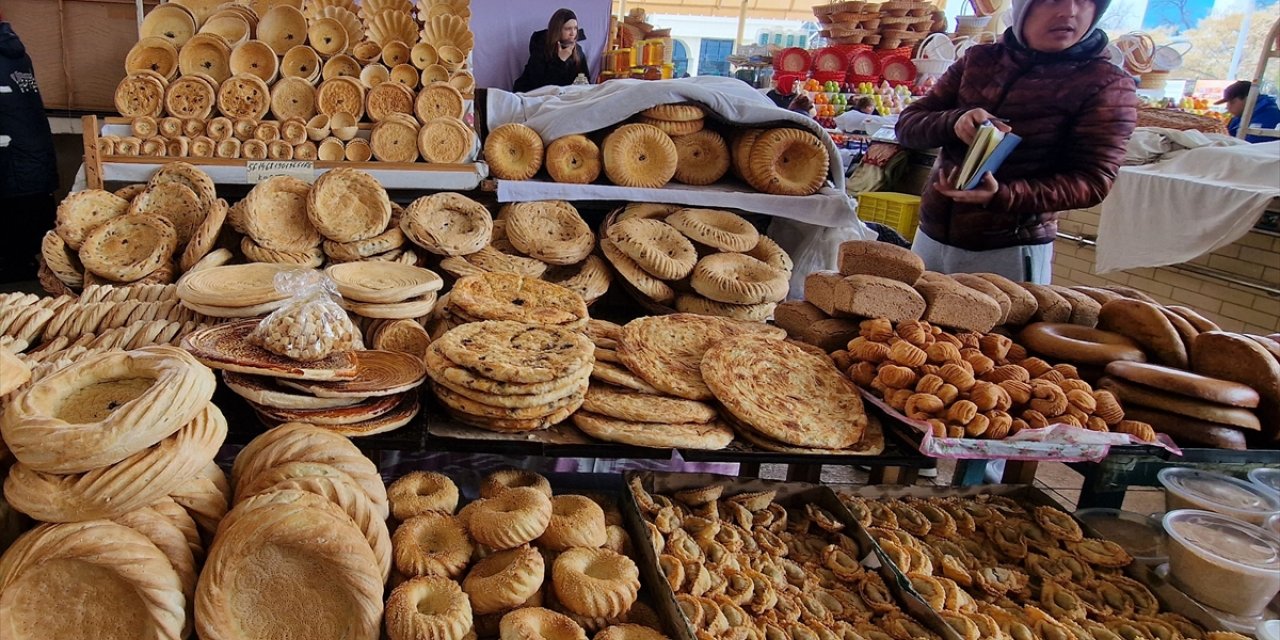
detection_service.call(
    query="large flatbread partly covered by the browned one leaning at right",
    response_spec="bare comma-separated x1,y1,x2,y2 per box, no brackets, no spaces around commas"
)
617,314,786,401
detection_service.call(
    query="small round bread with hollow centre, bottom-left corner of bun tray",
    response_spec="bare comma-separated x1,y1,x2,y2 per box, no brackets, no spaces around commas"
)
385,576,472,640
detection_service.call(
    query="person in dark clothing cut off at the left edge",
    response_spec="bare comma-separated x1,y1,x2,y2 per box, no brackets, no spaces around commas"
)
0,13,58,282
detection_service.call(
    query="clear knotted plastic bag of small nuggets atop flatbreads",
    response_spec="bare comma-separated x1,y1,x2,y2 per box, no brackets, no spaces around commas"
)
248,269,364,362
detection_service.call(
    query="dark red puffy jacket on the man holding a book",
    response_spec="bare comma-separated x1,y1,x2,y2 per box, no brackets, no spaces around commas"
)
897,31,1138,251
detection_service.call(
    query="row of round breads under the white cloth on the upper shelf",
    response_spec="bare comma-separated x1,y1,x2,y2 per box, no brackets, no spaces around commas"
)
484,104,828,196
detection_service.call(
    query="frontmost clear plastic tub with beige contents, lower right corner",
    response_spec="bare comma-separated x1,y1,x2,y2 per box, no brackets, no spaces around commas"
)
1164,509,1280,617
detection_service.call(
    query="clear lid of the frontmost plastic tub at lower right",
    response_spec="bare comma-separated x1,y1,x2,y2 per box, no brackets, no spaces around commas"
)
1165,509,1280,571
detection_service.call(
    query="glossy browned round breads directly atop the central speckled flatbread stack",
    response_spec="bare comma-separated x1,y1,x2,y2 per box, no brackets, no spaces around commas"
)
431,273,588,335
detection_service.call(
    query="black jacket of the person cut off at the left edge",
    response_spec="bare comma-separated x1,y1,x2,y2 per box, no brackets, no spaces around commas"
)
0,22,58,197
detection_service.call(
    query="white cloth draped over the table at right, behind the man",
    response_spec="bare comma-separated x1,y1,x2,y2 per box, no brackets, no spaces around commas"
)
1096,142,1280,274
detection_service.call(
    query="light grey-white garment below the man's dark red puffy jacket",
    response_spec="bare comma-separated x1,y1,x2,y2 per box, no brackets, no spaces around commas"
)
911,230,1053,284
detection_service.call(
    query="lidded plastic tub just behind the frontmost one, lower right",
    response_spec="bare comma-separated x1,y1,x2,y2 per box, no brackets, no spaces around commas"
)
1156,467,1280,526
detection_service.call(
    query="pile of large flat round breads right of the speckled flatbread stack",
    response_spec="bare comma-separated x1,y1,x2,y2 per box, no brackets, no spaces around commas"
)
573,314,868,453
